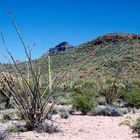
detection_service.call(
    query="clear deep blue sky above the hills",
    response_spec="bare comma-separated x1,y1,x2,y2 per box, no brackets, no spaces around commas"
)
0,0,140,62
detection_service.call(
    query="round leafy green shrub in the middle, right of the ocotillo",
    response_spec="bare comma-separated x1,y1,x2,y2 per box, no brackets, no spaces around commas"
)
71,87,97,114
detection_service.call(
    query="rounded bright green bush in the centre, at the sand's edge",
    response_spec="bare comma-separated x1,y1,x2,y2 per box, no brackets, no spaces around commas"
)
71,82,97,115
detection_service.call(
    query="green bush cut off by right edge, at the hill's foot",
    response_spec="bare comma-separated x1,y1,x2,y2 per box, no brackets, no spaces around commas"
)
125,88,140,108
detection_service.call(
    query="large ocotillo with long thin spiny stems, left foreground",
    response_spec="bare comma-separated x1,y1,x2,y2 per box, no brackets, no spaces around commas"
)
0,13,94,130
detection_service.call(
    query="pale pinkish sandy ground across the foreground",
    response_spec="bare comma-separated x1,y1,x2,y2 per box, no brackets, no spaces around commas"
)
4,114,140,140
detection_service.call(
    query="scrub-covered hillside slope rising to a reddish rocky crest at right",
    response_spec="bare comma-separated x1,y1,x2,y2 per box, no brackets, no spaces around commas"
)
3,33,140,80
